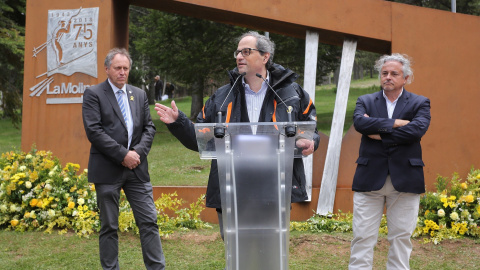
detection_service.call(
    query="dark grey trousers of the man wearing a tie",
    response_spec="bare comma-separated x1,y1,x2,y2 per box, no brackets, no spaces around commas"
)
95,168,165,269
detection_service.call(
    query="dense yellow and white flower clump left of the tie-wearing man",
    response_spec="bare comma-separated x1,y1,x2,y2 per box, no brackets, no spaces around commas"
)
0,150,100,236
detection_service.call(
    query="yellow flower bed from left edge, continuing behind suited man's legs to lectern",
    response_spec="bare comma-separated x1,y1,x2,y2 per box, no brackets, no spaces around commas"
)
0,149,209,237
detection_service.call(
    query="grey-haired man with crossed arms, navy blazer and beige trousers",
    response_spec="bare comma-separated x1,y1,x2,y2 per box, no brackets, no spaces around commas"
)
349,53,430,270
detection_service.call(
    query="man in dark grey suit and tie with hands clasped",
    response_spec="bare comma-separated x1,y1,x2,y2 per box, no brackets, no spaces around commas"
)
82,48,165,269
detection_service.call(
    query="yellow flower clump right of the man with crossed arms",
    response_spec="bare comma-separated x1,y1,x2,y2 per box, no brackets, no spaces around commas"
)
413,168,480,244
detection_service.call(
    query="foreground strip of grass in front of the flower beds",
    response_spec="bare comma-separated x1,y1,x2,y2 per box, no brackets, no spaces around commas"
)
0,229,480,270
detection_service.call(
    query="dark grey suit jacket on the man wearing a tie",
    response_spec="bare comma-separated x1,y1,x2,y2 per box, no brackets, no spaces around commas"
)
82,80,156,183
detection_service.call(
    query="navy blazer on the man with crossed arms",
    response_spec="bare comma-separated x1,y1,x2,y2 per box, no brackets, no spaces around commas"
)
352,90,431,194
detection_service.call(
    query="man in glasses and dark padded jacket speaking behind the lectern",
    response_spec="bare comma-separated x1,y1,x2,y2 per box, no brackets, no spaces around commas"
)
155,31,320,234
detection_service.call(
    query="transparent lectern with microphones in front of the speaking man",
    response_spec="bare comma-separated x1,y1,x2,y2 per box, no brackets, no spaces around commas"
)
195,121,316,270
